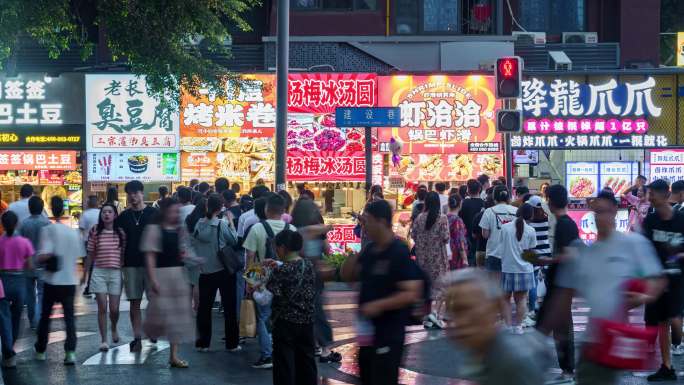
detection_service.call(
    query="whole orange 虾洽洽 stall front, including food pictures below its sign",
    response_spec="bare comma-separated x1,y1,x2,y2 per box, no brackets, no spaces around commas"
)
378,75,504,206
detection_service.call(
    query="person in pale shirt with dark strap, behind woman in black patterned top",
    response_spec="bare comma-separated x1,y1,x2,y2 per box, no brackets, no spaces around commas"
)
242,194,297,369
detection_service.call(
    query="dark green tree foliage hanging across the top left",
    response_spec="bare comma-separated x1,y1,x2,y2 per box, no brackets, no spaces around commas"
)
0,0,259,107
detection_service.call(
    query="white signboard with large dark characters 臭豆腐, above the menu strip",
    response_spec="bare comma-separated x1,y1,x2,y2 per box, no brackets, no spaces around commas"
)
86,74,180,153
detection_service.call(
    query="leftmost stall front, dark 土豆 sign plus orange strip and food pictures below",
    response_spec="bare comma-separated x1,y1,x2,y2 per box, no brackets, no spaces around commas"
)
0,73,84,221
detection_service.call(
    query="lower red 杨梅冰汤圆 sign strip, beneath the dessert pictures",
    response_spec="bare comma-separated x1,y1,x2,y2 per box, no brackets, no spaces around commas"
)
287,151,366,182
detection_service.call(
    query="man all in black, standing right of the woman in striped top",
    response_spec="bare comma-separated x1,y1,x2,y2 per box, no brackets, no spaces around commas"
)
116,180,157,352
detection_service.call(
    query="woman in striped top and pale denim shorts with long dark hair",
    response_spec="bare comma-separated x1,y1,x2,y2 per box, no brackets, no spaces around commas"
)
83,203,126,352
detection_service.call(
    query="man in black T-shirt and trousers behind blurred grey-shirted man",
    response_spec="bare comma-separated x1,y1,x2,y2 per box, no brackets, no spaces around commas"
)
536,184,580,380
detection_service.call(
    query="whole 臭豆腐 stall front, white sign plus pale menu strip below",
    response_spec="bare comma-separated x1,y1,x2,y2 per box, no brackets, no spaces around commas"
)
85,74,180,207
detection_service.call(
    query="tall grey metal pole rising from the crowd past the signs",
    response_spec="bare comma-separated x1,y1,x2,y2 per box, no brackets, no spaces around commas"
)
275,0,290,191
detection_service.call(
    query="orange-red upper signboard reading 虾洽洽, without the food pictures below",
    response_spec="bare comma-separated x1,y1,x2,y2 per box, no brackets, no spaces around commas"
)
378,75,501,154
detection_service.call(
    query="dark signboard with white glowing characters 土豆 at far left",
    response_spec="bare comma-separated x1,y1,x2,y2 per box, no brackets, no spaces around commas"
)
0,73,83,149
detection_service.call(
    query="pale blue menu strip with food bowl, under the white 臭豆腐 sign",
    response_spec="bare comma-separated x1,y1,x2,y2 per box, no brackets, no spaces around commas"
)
88,153,180,182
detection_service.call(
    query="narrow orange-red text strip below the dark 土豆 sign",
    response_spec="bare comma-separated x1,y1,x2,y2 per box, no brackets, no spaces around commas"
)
0,150,77,170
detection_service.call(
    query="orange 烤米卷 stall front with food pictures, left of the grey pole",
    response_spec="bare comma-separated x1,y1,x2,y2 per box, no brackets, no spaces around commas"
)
180,74,275,191
